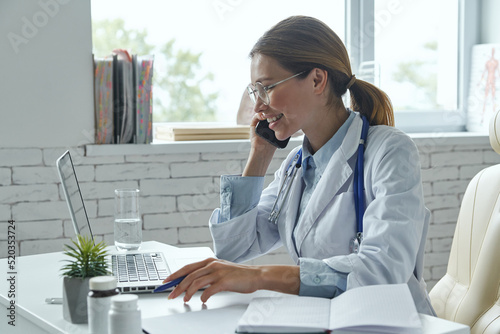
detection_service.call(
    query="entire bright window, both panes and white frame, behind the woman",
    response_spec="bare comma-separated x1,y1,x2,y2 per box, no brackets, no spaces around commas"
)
92,0,479,132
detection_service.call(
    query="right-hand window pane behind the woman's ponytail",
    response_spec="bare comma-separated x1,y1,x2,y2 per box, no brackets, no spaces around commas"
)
374,0,458,111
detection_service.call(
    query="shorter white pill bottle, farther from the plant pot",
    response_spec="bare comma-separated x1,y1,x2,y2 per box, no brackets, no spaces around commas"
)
108,294,142,334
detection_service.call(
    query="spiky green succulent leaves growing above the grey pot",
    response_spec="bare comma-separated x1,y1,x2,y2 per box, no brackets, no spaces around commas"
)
61,235,111,279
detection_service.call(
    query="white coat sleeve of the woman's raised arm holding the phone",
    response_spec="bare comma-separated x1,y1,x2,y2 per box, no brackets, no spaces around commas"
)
209,149,298,262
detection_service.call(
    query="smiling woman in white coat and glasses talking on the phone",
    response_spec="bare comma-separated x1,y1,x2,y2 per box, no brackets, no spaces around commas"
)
165,16,434,314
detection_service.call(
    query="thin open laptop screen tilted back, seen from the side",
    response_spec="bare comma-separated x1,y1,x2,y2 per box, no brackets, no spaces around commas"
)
56,151,93,239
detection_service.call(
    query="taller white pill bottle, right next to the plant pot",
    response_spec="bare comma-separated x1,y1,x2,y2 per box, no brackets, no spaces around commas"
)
87,276,120,334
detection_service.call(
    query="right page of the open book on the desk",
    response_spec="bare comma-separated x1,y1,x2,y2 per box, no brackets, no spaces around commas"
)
330,284,422,333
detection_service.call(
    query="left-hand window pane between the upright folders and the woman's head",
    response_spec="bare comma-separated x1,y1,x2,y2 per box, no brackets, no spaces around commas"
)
92,0,345,122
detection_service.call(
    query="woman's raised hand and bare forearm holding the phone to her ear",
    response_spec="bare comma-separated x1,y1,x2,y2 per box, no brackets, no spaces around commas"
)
242,112,276,176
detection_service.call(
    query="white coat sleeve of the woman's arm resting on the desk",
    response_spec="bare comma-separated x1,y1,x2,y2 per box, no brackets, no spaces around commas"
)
324,130,429,289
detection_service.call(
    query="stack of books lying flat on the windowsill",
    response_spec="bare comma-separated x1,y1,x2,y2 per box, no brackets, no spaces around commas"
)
155,123,250,141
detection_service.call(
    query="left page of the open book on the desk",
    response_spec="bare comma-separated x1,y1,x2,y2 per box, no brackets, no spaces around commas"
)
237,296,330,333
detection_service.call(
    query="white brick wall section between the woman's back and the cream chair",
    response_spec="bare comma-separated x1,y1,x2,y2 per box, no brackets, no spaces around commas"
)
416,140,500,289
